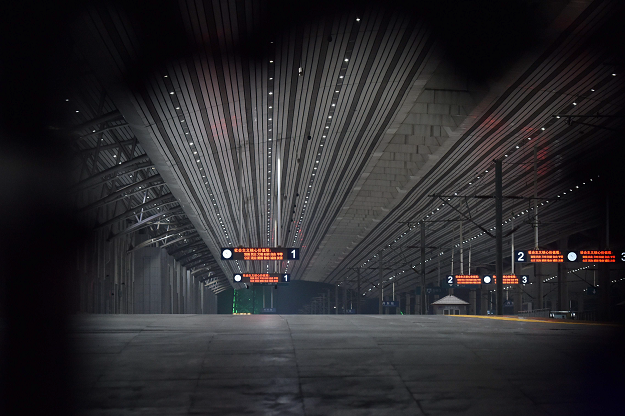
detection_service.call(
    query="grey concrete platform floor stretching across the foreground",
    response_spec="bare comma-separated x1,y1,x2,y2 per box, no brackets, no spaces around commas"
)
72,315,625,416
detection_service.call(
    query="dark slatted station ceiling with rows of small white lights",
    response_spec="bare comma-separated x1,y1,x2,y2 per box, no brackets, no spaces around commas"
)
5,1,625,292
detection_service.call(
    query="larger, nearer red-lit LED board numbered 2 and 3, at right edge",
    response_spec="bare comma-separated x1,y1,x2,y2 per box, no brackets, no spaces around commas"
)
514,250,625,263
